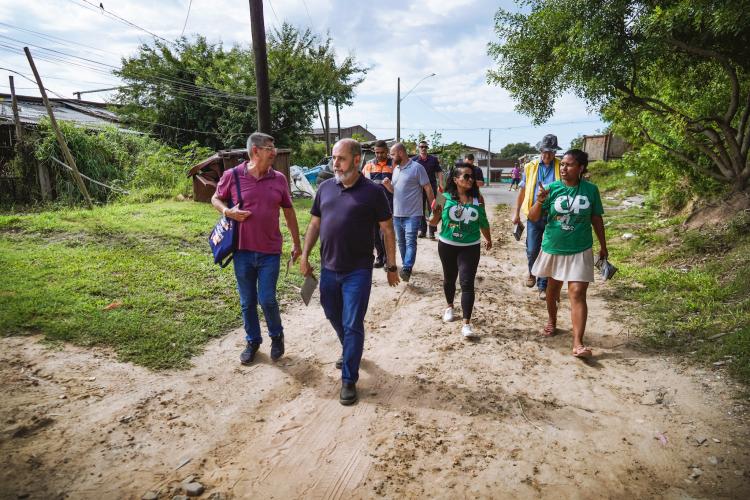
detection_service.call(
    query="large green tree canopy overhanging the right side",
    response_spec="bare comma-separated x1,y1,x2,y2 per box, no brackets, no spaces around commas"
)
488,0,750,190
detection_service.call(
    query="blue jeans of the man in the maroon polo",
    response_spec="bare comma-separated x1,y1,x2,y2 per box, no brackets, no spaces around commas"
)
233,250,284,344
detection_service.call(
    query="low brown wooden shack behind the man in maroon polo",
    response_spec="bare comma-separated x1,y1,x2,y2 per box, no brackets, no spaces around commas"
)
187,148,292,203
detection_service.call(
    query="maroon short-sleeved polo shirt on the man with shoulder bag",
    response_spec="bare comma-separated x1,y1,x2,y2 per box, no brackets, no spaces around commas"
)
216,161,292,254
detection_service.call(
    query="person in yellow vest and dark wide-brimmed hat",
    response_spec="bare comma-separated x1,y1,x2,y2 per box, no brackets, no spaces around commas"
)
513,134,562,300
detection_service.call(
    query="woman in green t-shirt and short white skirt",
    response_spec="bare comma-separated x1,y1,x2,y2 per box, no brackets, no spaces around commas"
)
529,149,607,358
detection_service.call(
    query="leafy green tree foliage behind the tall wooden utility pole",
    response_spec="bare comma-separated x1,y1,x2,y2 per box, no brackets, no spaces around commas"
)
115,23,366,149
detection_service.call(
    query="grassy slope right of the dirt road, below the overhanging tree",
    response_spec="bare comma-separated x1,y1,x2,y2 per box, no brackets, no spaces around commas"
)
592,164,750,383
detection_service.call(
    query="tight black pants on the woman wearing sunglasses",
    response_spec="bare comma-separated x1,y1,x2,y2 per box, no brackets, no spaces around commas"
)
438,241,480,319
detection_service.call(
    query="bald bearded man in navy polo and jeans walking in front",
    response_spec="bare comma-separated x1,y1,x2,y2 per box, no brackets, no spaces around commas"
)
300,139,399,405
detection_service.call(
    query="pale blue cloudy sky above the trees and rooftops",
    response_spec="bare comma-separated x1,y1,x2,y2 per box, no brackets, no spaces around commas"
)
0,0,604,151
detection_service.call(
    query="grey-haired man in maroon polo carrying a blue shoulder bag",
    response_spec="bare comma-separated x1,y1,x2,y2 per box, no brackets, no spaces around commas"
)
211,132,302,365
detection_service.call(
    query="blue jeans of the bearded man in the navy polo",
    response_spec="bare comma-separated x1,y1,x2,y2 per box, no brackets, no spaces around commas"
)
320,268,372,382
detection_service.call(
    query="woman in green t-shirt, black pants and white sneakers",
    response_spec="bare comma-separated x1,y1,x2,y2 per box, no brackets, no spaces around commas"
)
430,163,492,338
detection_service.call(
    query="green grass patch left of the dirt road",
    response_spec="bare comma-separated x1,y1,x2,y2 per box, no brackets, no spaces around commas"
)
0,200,317,369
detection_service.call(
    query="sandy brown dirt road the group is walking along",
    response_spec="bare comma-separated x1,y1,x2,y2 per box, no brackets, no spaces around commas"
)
0,188,750,499
